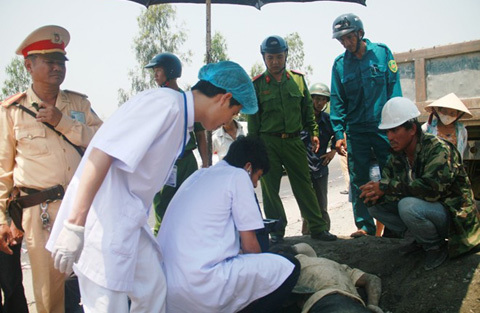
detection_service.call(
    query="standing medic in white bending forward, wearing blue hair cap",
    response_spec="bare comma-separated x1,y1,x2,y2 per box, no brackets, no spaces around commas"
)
47,61,257,313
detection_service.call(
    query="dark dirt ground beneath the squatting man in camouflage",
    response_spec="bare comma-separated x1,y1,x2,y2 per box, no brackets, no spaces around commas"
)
280,236,480,313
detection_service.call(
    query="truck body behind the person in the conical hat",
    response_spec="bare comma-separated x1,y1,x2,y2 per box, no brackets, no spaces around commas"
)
394,40,480,200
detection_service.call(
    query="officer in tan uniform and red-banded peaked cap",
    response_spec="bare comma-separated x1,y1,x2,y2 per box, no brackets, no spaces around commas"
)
0,25,102,313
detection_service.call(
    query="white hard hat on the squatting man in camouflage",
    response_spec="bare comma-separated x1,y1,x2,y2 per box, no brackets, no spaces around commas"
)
378,97,420,129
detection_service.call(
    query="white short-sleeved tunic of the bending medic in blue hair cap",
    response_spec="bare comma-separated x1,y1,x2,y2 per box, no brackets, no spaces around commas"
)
47,88,194,292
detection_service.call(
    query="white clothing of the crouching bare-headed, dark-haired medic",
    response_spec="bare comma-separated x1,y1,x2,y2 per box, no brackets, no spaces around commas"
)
157,161,294,313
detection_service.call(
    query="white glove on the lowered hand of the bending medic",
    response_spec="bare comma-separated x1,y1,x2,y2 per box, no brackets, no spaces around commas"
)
52,221,85,275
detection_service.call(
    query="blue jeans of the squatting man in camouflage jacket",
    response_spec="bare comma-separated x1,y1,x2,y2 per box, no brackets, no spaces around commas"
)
368,197,449,250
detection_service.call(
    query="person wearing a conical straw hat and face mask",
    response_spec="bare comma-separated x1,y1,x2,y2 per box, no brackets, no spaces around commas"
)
422,93,473,157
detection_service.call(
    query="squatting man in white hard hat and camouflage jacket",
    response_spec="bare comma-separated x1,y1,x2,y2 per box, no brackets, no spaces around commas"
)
360,97,480,270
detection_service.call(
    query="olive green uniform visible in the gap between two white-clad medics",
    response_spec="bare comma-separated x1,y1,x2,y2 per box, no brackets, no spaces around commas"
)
153,123,204,236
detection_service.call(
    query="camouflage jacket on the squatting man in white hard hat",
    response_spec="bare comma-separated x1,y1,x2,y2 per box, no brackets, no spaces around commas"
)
380,134,480,257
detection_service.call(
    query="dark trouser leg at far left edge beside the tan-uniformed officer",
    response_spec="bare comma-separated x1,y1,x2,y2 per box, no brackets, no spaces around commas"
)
0,244,28,313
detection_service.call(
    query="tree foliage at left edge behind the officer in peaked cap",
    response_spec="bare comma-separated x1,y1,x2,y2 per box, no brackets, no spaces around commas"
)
2,57,32,98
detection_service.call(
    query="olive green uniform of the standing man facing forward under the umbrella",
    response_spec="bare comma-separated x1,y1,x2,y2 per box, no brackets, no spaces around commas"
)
248,71,327,237
